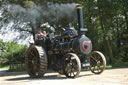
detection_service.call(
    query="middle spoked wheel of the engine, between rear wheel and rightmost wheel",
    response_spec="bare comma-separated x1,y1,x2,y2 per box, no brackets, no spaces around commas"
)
63,54,81,78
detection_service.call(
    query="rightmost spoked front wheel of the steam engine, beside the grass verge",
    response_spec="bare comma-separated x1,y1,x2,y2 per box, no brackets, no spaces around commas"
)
89,51,106,74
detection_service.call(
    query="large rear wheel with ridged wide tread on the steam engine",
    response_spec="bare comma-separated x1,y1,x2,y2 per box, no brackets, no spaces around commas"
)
25,45,47,77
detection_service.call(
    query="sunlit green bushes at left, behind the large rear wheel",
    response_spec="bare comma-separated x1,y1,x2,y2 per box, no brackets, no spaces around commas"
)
0,41,27,64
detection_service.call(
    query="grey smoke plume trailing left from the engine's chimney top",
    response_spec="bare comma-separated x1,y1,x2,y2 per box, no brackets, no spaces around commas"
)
9,3,77,27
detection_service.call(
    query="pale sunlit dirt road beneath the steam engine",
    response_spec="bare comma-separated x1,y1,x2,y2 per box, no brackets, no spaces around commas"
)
0,68,128,85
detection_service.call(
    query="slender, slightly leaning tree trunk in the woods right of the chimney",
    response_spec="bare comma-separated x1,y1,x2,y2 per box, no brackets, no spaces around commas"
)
98,0,114,64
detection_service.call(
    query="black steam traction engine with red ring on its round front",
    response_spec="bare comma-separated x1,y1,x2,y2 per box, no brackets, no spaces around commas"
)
25,5,106,78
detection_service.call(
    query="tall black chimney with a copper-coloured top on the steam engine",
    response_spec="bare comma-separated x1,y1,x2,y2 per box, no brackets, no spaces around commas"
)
76,5,87,35
